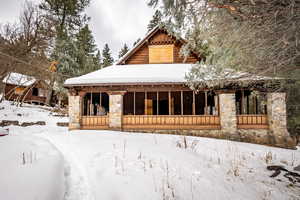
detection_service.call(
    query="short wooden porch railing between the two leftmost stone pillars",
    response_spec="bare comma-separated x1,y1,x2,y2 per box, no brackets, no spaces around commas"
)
81,115,108,129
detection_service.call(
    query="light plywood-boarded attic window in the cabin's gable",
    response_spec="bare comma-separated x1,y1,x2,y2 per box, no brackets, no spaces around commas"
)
149,45,174,63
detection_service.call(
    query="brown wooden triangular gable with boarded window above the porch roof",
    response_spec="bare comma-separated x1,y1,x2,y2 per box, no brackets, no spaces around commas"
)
118,29,200,64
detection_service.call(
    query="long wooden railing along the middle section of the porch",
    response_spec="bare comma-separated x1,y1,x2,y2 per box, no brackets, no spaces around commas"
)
122,115,220,130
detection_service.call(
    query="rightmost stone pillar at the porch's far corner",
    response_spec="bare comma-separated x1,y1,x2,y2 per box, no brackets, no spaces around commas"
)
267,93,289,137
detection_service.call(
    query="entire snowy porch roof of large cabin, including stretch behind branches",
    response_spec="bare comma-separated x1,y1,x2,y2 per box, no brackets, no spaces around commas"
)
65,64,271,86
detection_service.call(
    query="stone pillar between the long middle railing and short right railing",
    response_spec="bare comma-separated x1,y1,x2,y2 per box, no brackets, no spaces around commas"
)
219,93,237,136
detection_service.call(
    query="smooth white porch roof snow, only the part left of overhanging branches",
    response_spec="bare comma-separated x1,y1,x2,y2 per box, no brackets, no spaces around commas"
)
65,64,192,85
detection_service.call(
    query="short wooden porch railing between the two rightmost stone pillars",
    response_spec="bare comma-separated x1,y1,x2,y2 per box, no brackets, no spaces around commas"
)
237,115,269,129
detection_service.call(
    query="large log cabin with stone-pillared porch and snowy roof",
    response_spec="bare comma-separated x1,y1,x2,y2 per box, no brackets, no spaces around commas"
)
64,27,294,147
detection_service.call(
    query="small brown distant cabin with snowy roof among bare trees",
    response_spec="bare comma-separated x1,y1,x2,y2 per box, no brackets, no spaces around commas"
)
3,72,48,104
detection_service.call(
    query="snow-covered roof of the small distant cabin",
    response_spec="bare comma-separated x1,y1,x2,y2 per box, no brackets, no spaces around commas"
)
2,72,36,86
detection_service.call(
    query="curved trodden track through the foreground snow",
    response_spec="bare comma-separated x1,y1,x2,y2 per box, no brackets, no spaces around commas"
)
41,135,95,200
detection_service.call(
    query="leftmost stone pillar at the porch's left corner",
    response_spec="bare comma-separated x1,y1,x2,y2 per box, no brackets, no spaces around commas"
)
69,95,82,130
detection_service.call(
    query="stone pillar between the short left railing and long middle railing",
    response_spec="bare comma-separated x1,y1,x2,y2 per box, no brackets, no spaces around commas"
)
109,91,125,130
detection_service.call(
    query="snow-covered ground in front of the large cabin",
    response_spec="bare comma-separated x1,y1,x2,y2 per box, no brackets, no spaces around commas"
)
0,102,300,200
